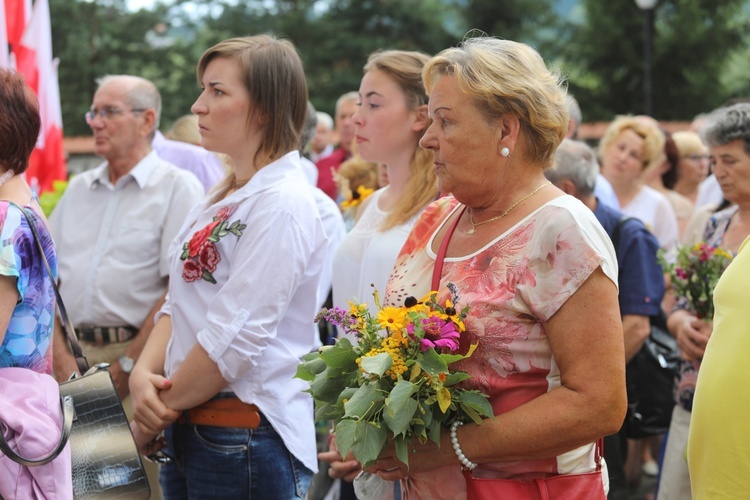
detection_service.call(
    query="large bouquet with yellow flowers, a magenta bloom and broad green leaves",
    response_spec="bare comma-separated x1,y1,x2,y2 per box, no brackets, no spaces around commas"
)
296,283,493,467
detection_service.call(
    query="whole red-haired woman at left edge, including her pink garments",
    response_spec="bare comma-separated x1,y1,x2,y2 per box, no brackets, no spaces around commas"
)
0,68,73,499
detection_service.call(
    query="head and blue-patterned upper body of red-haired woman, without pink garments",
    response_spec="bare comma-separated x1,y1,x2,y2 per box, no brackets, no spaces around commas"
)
0,69,57,374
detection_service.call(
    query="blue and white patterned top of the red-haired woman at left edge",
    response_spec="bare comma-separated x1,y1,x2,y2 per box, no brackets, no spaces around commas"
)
0,201,57,374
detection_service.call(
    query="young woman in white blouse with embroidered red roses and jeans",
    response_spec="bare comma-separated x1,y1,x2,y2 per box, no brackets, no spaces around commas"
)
130,35,327,499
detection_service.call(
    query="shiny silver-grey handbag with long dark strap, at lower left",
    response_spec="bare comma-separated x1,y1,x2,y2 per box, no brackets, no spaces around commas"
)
3,203,151,500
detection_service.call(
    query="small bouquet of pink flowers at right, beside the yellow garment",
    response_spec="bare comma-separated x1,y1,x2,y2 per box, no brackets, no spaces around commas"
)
660,242,732,321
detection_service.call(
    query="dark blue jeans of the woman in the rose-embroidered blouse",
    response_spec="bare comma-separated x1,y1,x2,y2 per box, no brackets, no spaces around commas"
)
160,414,312,500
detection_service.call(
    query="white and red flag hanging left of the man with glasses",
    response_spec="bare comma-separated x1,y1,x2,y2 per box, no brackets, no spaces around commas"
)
15,0,67,193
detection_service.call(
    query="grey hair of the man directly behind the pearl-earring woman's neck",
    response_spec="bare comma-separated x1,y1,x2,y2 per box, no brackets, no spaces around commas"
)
544,139,599,198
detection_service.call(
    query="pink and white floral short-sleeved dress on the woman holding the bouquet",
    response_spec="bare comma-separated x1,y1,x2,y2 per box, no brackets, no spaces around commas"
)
385,196,617,499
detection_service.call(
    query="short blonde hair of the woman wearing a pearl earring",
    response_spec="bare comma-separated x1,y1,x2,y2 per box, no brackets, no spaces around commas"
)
422,37,569,168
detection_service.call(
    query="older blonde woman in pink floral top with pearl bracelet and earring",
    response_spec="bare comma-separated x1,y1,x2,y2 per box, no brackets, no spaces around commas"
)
368,38,626,499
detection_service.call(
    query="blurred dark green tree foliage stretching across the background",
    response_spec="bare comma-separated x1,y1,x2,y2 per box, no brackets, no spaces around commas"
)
50,0,750,136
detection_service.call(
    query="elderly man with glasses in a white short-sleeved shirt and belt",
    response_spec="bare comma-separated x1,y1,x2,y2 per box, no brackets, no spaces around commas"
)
49,75,204,496
